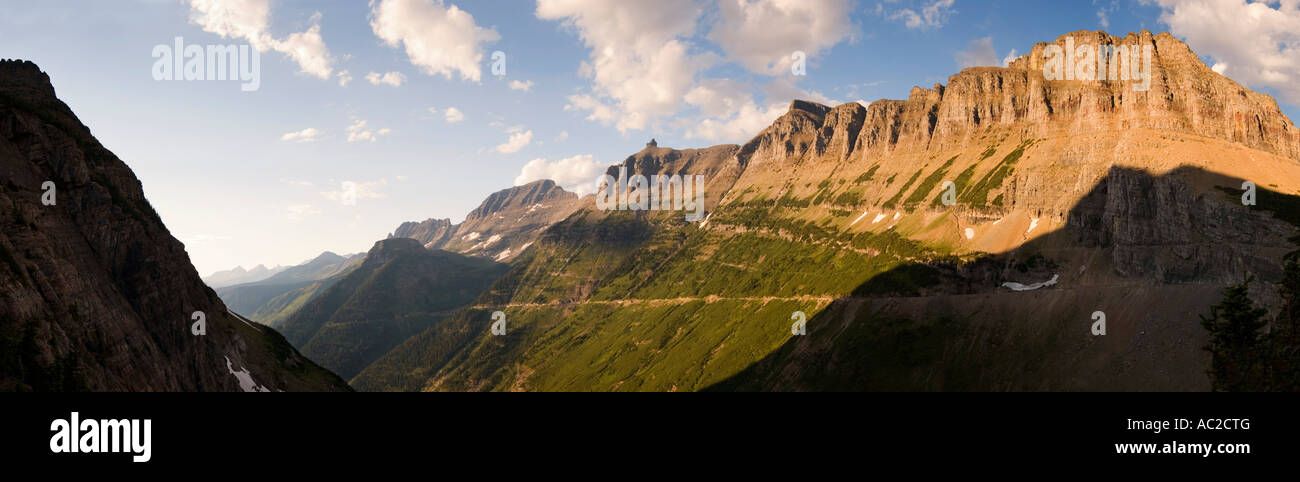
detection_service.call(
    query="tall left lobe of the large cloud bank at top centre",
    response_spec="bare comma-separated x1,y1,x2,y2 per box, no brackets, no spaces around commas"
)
537,0,716,133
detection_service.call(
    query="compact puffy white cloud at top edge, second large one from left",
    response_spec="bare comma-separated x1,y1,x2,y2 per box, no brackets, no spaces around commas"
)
371,0,501,82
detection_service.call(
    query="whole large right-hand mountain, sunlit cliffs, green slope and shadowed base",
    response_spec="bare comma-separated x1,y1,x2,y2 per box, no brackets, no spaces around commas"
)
351,31,1300,391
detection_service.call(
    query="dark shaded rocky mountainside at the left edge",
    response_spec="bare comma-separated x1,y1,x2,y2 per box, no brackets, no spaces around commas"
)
0,61,350,391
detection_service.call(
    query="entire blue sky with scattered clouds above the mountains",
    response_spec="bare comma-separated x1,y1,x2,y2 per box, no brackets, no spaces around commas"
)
0,0,1300,275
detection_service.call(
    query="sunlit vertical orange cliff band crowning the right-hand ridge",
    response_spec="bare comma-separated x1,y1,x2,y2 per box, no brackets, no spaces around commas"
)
738,31,1300,166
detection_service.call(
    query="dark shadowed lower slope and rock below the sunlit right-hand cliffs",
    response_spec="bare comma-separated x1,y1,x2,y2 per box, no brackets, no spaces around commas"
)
706,166,1300,391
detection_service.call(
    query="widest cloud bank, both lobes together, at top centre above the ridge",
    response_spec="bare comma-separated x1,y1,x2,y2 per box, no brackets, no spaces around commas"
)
537,0,854,142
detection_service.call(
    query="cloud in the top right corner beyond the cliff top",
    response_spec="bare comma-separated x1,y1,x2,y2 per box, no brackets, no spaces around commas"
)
1145,0,1300,105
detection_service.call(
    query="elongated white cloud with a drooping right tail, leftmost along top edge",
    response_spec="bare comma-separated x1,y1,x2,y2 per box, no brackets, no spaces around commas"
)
189,0,334,79
